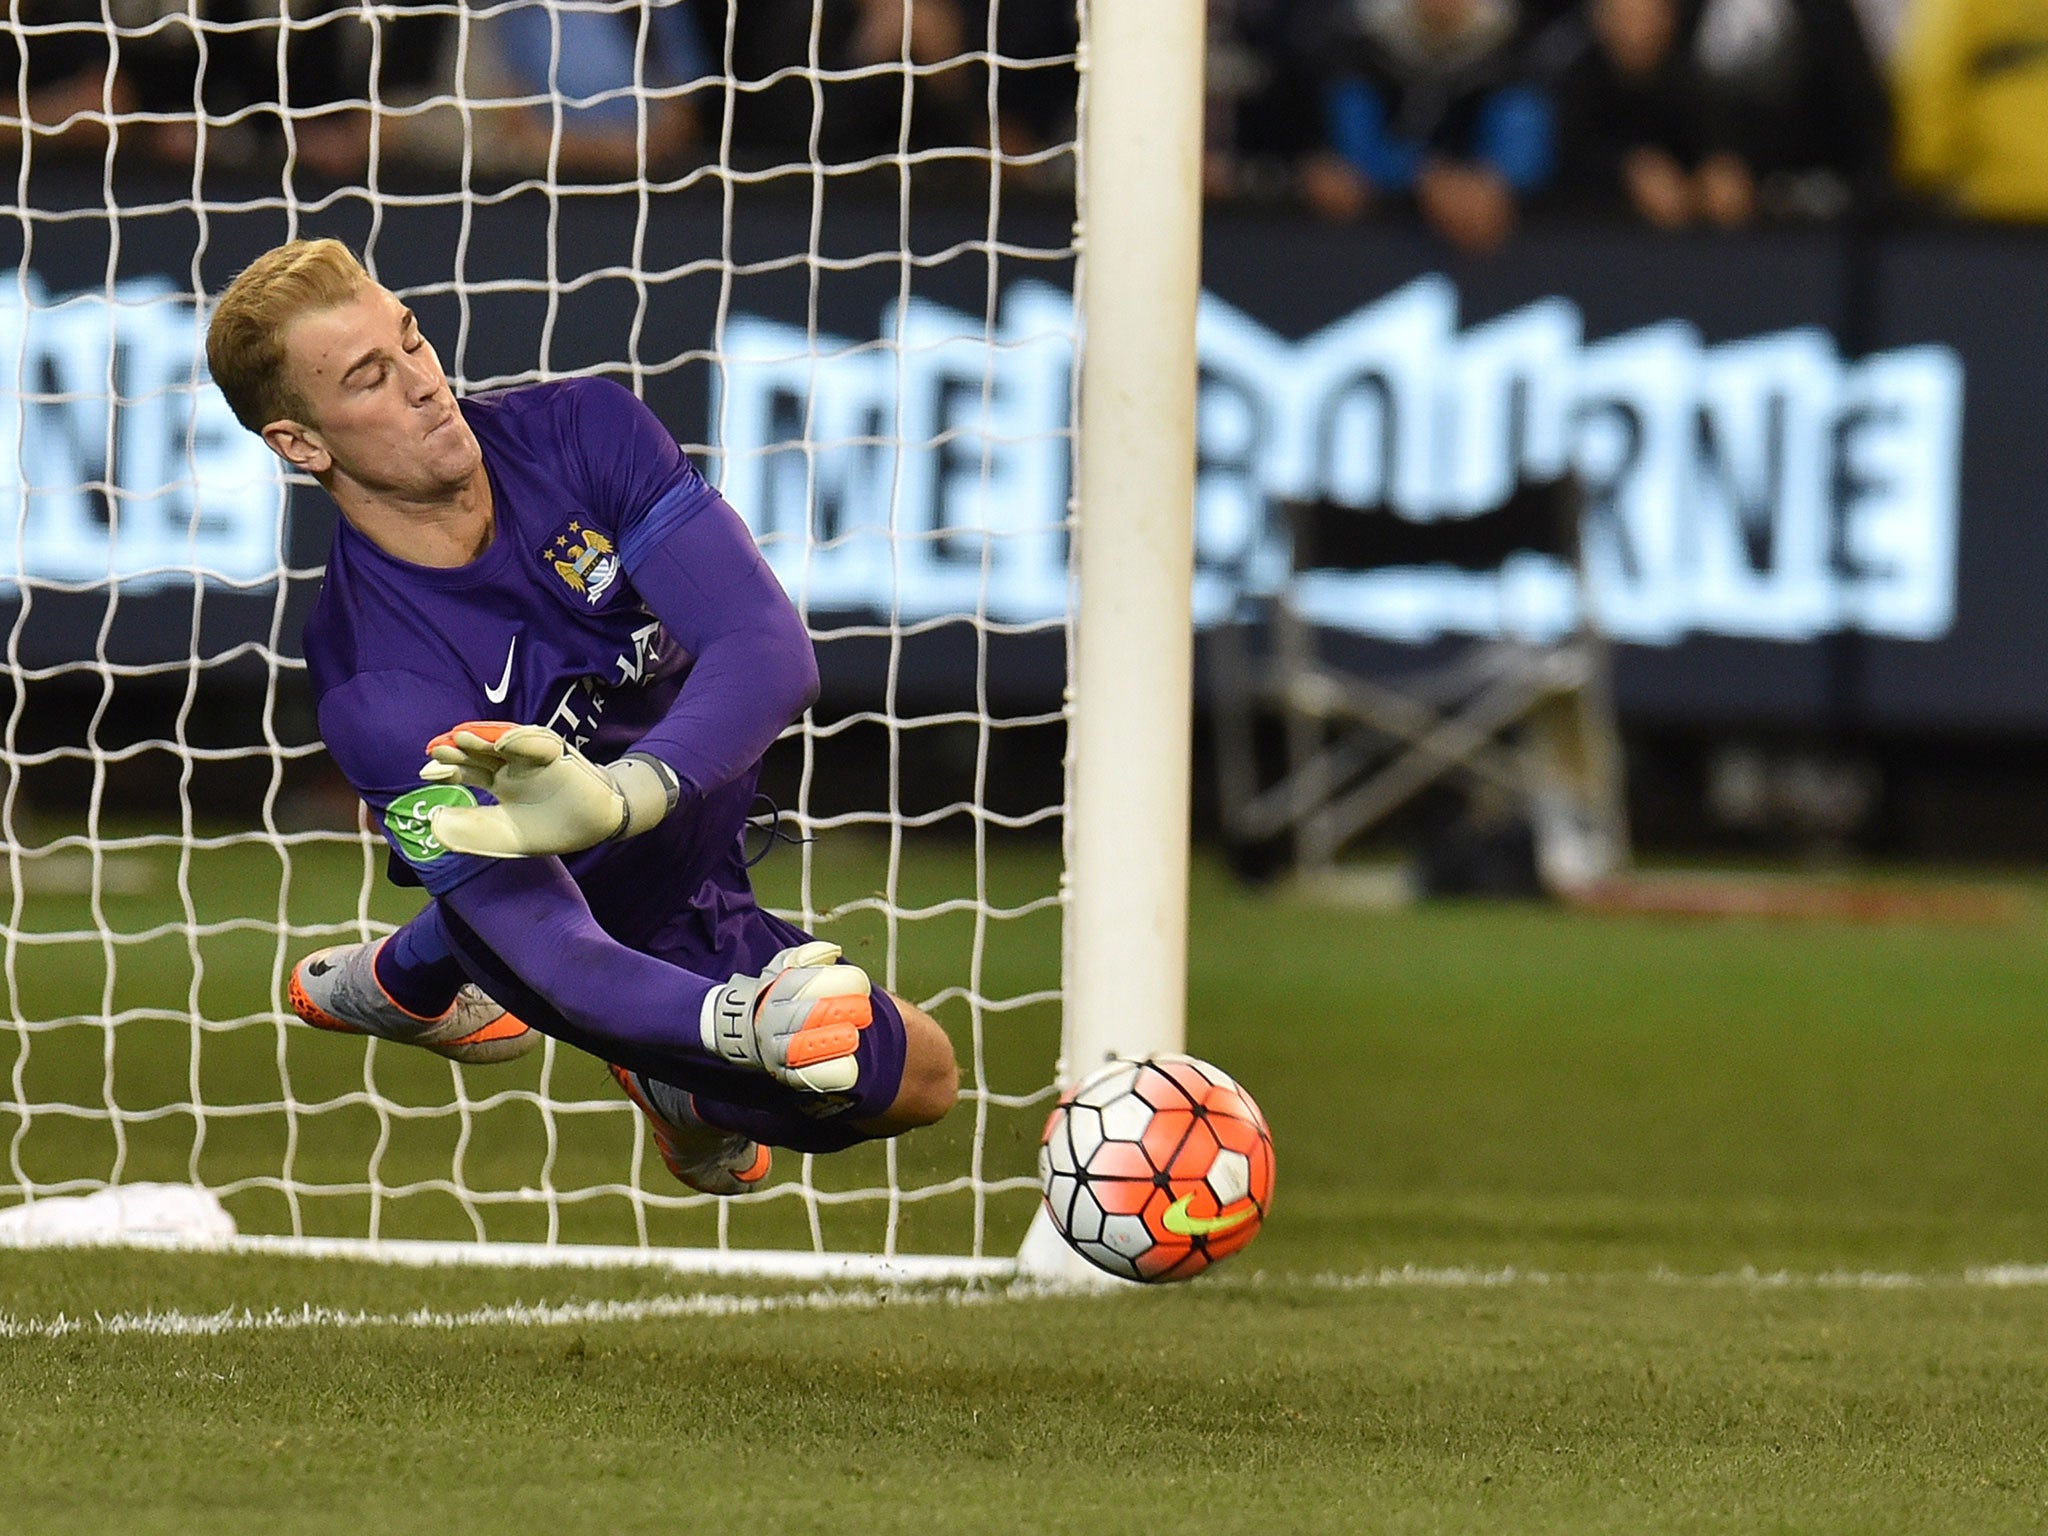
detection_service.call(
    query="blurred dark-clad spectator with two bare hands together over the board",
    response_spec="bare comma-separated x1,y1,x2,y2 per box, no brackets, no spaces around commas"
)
1544,0,1757,229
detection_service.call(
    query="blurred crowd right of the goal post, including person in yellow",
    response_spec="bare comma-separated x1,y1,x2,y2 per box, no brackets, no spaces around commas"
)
1208,0,2048,250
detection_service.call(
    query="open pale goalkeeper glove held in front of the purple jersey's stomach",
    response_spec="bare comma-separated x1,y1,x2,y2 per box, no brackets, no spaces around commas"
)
420,721,680,858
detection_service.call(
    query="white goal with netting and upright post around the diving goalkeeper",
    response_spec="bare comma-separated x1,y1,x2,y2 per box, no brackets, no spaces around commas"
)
0,0,1204,1278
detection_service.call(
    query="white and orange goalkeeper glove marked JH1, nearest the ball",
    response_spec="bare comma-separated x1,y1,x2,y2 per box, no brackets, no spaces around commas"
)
698,940,874,1094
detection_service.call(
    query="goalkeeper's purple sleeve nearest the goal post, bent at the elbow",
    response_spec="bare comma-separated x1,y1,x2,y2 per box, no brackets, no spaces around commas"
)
575,379,817,803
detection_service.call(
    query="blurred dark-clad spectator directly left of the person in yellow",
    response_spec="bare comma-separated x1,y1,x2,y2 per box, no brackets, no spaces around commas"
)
1692,0,1892,217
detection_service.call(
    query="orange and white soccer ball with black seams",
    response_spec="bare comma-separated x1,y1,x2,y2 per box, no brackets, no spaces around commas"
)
1038,1055,1274,1280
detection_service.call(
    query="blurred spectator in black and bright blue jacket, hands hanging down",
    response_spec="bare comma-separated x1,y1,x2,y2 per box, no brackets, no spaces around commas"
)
1303,0,1554,252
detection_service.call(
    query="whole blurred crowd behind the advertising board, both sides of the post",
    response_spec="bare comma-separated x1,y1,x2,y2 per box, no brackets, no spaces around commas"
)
0,0,2048,250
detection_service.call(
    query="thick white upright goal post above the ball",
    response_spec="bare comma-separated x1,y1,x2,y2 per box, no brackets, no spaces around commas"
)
1061,0,1204,1077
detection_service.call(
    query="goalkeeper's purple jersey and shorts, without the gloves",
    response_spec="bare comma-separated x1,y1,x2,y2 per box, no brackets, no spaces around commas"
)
305,379,921,1151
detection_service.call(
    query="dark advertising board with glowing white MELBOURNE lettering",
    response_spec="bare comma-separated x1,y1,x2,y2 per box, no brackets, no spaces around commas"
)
0,188,2048,731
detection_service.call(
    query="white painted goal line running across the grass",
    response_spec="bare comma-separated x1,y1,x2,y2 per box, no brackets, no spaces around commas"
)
12,1264,2048,1341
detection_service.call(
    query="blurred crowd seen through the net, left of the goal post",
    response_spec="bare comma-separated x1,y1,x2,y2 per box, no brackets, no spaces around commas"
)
0,0,1075,182
